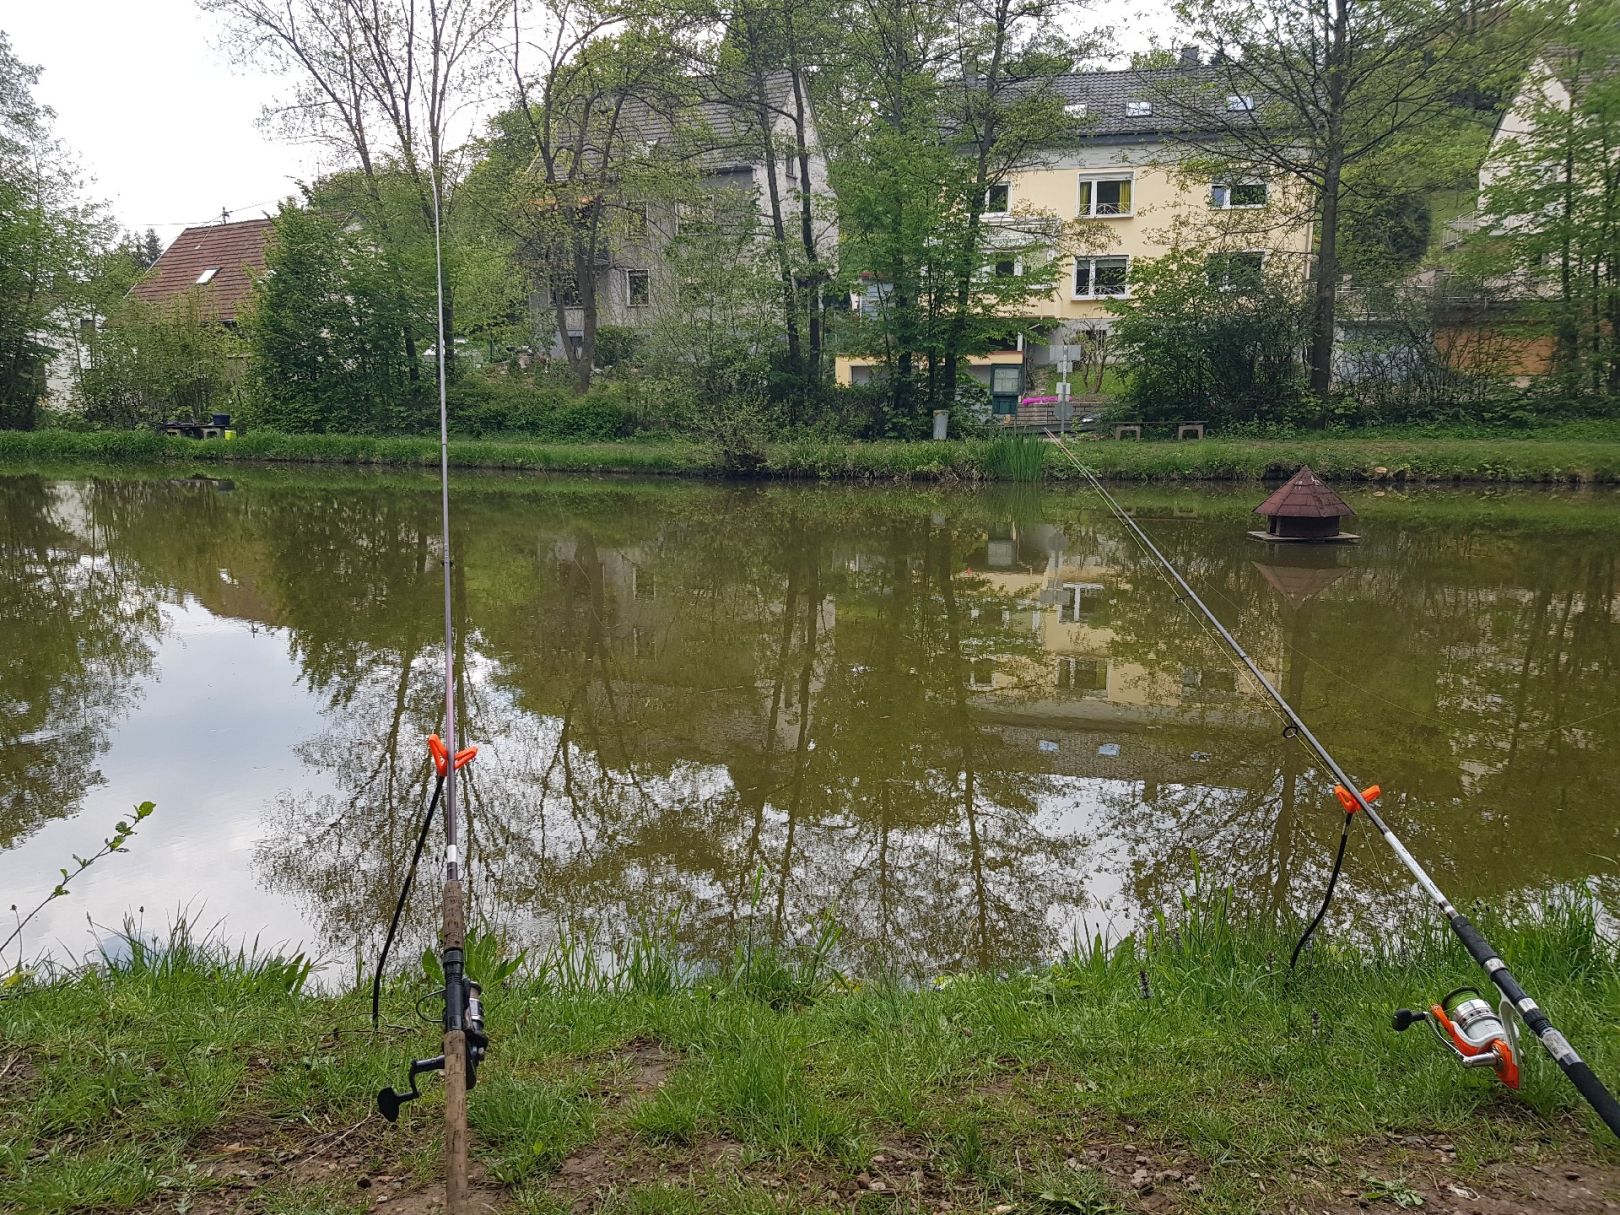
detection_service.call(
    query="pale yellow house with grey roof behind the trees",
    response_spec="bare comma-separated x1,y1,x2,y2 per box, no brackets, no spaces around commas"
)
836,61,1311,401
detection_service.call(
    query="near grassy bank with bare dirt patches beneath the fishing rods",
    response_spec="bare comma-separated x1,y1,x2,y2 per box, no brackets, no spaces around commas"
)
0,901,1620,1215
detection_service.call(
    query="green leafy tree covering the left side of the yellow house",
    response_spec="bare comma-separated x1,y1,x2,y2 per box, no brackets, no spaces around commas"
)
834,0,1077,434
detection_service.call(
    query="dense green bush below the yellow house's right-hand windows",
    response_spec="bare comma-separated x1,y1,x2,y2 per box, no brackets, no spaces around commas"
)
1110,251,1306,423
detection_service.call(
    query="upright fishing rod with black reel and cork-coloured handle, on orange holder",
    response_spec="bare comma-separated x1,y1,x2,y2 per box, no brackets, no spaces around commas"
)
373,143,489,1215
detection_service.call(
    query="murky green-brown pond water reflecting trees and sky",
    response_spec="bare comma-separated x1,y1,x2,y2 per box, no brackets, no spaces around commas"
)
0,473,1620,974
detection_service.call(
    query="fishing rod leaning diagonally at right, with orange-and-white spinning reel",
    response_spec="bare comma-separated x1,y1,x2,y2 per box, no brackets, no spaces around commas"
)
1047,431,1620,1137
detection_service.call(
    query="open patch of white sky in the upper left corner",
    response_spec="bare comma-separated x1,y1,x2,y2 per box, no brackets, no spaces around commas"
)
0,0,318,245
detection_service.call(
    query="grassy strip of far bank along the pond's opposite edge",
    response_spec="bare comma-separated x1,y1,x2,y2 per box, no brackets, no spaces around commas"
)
0,431,1620,484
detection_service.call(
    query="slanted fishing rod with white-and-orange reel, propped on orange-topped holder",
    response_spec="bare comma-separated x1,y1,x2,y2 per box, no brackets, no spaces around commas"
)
1047,431,1620,1137
